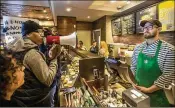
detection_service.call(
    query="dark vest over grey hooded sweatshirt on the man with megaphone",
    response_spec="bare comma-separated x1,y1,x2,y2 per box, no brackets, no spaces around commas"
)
14,39,58,107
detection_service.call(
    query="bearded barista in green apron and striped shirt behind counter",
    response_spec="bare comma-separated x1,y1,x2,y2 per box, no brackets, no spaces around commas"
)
131,20,175,107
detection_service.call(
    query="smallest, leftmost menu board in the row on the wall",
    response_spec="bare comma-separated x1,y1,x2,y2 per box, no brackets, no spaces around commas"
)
112,18,122,36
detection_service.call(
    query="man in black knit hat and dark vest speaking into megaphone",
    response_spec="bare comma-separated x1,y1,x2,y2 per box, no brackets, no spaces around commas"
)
14,20,60,107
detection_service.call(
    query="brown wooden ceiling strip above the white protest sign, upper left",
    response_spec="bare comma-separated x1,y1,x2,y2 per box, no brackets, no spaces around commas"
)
0,3,53,20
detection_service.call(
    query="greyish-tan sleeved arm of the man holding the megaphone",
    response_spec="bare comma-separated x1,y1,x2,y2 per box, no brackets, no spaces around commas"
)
25,50,58,86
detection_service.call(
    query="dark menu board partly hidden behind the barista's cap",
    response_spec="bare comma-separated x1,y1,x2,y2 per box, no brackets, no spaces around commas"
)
136,6,157,33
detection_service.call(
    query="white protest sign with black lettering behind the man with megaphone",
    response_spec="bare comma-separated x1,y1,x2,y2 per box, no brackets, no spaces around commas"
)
3,16,39,50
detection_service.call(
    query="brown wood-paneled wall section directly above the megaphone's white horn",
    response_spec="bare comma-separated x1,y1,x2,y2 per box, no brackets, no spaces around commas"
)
57,16,76,36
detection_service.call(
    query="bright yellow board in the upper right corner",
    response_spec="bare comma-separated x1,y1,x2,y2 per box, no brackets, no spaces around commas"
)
158,1,175,31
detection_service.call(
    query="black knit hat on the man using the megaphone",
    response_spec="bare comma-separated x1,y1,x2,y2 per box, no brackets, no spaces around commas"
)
21,20,42,37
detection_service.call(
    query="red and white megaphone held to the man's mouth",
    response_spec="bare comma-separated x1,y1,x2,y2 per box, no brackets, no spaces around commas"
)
45,32,76,47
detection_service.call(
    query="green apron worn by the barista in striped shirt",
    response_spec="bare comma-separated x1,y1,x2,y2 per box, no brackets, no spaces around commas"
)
135,41,169,107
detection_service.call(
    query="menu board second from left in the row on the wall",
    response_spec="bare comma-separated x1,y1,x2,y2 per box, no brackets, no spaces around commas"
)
122,14,135,35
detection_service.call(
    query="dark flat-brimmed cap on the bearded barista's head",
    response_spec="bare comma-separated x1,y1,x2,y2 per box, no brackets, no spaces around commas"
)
139,19,162,27
